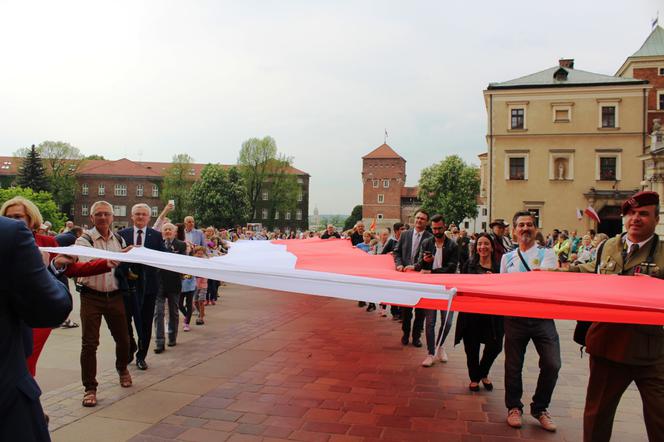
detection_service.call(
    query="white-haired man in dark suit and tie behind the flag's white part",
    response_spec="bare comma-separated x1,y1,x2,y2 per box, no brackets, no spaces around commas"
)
118,203,166,370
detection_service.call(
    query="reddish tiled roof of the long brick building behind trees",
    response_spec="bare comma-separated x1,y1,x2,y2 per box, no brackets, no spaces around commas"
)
0,156,308,178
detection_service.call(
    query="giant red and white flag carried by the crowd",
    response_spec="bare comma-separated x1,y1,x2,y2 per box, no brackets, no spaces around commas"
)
43,239,664,325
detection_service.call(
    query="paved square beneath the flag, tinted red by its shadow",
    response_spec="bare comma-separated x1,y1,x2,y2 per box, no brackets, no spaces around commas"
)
40,285,646,442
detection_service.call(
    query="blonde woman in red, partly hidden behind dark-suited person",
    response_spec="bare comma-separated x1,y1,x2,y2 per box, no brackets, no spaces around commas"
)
0,196,115,376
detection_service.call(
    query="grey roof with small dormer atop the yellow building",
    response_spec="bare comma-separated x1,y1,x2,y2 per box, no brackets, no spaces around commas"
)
488,66,647,89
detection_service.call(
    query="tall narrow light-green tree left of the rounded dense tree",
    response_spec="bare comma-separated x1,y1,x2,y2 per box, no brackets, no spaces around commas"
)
161,153,194,222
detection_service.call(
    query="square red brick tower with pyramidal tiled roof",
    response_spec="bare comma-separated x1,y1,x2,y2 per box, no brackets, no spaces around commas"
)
362,144,406,229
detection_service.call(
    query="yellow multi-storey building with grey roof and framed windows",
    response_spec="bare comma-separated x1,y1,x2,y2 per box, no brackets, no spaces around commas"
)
484,60,650,238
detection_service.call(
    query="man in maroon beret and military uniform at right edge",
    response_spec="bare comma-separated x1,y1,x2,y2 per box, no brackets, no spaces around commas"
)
570,192,664,442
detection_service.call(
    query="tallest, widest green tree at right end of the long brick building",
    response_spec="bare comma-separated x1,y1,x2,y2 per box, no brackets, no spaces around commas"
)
237,136,300,219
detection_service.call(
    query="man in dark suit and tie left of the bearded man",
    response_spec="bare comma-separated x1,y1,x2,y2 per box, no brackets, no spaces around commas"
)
394,210,432,347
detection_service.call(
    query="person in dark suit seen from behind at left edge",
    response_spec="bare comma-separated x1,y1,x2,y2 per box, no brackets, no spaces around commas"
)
0,217,72,441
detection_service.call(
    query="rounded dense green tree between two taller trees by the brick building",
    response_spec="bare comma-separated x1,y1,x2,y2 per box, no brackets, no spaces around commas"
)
191,164,250,227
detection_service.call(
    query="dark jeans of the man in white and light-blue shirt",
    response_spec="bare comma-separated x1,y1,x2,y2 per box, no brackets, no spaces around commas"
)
505,317,560,416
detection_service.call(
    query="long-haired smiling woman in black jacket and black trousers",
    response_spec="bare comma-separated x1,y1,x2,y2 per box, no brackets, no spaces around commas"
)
454,233,505,391
